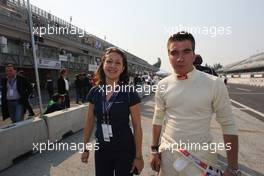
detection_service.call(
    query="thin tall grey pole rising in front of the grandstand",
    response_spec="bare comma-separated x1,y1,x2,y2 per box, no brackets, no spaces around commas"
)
27,0,43,114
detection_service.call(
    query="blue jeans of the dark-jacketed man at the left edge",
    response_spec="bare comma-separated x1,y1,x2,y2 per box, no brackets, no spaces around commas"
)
7,100,24,123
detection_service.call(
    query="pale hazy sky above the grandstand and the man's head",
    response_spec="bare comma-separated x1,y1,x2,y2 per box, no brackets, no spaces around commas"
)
30,0,264,71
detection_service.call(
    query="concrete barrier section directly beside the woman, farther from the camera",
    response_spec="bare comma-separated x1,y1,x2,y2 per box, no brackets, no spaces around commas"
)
43,105,88,142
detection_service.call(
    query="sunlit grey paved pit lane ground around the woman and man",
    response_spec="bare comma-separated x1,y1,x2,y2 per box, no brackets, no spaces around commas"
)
0,93,264,176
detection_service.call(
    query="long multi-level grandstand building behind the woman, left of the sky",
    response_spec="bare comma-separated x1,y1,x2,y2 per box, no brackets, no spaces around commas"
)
0,0,158,86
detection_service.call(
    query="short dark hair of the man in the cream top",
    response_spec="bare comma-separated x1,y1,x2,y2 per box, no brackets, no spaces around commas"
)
167,31,195,52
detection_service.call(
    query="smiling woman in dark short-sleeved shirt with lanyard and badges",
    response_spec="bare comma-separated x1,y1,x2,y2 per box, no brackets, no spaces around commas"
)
81,48,144,176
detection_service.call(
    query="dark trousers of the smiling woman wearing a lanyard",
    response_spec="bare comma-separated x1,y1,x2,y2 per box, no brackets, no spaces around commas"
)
95,150,134,176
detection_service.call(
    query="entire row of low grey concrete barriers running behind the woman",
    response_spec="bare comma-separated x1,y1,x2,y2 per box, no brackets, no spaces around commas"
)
0,92,151,171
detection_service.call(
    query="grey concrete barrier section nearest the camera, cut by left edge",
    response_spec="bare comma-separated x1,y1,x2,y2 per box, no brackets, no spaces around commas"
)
0,118,48,171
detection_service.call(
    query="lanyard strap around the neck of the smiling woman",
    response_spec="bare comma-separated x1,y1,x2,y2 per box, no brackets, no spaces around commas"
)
102,88,119,124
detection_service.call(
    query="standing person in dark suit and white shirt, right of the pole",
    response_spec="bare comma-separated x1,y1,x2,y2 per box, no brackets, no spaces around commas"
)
57,68,70,108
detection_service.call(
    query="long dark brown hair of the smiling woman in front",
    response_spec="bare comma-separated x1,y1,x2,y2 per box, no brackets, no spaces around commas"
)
95,47,128,85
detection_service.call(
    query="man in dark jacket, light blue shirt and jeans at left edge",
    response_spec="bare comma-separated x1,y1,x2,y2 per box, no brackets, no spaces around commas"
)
1,64,32,123
